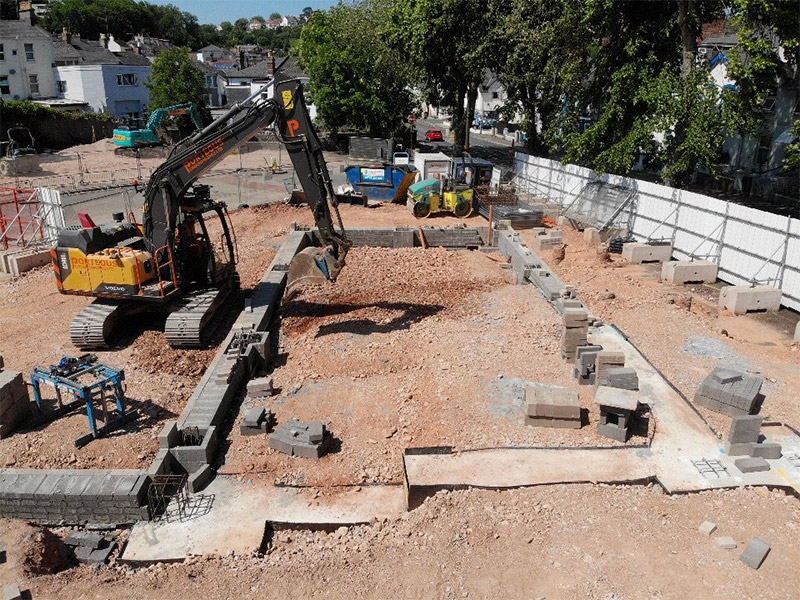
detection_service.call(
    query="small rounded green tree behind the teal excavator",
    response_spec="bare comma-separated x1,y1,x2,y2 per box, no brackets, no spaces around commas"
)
146,48,210,121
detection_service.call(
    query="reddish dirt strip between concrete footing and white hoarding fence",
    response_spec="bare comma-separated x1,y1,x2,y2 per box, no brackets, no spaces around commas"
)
523,230,800,434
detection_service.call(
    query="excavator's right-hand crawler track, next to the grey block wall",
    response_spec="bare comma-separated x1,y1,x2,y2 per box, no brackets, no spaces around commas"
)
164,276,238,348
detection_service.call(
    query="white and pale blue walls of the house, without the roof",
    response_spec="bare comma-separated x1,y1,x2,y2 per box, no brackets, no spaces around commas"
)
55,65,150,119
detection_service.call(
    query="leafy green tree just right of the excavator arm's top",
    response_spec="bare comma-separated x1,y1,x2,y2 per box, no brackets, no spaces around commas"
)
296,0,414,135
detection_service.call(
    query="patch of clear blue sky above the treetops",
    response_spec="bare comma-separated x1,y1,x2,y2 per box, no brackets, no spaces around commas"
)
150,0,337,25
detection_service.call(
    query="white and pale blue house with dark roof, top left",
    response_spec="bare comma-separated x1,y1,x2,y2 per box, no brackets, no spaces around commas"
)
52,35,151,119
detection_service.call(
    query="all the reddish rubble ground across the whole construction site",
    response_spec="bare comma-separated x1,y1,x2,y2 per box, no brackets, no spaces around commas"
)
0,196,800,600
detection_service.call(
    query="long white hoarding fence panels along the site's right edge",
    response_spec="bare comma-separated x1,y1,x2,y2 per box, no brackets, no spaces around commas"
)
514,152,800,310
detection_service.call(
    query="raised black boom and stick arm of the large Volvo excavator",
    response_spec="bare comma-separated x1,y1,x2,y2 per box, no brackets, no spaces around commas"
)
143,80,351,287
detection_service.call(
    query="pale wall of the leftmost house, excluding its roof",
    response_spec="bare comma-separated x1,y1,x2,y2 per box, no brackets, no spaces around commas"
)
0,36,56,100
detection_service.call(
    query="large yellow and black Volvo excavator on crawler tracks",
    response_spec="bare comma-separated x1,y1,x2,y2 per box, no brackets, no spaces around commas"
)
52,80,350,348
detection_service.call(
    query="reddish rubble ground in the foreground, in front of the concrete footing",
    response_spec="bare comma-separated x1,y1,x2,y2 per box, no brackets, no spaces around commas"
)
0,485,800,600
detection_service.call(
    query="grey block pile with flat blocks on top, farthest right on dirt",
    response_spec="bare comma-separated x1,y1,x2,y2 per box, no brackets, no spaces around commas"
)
694,367,764,417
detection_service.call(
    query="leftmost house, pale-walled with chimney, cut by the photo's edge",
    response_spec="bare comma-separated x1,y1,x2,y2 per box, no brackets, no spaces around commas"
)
0,16,56,100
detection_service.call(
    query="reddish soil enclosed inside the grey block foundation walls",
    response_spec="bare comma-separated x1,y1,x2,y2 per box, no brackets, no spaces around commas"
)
220,248,646,487
